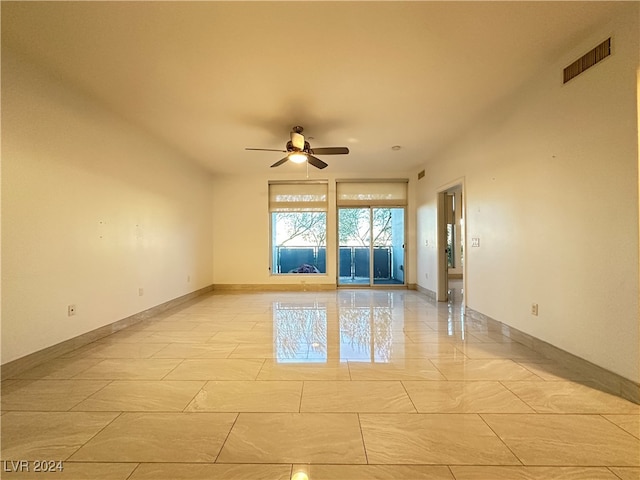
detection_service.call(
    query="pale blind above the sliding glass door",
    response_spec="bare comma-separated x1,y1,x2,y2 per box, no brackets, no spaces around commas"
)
336,180,407,207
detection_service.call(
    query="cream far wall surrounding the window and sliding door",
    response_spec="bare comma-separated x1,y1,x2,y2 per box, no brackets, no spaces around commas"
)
213,172,415,286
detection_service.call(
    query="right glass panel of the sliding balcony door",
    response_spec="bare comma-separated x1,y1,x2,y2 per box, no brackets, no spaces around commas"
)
372,208,404,285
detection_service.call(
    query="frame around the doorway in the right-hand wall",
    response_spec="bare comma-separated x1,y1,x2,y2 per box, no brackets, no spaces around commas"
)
436,177,468,302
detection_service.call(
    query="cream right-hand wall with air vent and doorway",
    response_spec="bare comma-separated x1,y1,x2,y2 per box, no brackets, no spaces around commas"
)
416,6,640,382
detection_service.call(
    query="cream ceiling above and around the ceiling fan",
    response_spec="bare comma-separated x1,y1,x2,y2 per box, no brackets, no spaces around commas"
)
2,1,618,174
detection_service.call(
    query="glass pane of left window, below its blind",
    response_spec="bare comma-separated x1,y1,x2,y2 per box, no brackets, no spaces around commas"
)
271,212,327,274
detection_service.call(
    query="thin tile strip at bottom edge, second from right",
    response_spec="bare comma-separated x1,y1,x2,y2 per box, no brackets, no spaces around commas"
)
451,466,618,480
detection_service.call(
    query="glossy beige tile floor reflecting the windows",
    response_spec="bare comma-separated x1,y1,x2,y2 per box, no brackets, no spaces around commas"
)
0,290,640,480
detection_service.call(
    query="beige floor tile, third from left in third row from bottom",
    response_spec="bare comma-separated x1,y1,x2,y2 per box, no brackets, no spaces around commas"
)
186,381,302,412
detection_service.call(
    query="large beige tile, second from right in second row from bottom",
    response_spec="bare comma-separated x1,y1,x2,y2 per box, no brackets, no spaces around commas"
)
482,414,640,466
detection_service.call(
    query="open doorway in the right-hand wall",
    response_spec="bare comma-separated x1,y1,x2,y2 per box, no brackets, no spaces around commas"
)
437,181,465,302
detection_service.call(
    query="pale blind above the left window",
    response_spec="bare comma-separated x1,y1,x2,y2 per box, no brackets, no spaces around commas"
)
269,182,328,212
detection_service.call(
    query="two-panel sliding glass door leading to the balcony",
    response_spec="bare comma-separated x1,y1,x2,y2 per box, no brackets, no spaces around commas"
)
338,206,405,286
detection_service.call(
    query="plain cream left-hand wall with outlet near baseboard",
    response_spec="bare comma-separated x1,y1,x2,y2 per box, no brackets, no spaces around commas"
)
2,48,213,364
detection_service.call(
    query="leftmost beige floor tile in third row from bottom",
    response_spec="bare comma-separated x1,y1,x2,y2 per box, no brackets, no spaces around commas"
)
2,379,109,411
